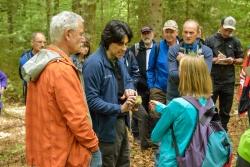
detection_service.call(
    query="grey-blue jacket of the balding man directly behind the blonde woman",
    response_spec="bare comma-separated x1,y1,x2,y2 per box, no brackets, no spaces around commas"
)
167,41,213,101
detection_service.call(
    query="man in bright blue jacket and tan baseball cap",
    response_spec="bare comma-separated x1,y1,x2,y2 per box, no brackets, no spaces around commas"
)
147,20,178,104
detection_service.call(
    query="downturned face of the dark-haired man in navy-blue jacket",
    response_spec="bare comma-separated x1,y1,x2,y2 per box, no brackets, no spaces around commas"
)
107,35,128,59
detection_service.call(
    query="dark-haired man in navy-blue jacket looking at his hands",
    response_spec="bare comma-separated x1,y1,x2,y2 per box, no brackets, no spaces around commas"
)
83,20,137,167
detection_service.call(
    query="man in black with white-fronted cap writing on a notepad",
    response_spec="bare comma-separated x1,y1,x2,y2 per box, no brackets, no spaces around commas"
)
205,16,243,131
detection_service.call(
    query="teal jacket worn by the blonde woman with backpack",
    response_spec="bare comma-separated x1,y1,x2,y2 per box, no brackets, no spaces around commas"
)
151,98,207,167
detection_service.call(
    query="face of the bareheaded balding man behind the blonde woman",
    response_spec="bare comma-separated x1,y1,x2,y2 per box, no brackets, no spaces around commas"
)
182,22,199,44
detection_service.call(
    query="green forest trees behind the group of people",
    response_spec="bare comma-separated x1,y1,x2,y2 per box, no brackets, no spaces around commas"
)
0,0,250,102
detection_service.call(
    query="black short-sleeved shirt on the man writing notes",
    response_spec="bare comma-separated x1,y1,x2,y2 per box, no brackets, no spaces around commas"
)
205,33,243,85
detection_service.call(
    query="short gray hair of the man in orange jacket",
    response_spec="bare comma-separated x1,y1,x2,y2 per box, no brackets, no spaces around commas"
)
50,11,84,43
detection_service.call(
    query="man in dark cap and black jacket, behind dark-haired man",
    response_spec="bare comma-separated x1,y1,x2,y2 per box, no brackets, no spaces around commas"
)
125,26,155,150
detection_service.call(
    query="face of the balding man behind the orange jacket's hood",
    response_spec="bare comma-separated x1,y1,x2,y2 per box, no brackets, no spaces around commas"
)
31,33,46,54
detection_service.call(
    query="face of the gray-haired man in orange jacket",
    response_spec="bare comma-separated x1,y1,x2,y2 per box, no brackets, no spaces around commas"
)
67,21,85,54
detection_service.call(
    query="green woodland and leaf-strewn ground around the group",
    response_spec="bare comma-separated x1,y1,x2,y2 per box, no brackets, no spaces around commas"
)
0,0,250,167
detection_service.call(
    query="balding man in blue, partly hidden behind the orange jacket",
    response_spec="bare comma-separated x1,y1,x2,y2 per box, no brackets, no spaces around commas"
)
19,32,46,102
